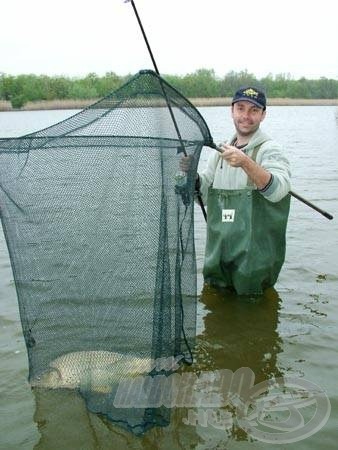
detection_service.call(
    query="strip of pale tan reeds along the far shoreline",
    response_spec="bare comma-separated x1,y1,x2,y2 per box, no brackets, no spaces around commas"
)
0,97,338,112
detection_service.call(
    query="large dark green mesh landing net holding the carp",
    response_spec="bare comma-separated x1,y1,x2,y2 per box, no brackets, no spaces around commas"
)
0,71,211,430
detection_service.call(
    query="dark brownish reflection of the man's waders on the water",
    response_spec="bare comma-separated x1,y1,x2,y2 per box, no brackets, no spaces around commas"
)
193,286,281,382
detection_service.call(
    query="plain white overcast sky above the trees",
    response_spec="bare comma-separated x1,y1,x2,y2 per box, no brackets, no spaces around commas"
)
0,0,338,80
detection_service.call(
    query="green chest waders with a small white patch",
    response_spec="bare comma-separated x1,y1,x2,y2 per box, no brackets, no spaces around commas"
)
203,146,290,295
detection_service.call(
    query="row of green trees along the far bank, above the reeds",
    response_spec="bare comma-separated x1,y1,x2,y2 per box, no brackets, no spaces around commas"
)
0,69,338,108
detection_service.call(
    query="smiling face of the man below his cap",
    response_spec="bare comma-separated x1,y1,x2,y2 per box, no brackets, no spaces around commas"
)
231,100,266,137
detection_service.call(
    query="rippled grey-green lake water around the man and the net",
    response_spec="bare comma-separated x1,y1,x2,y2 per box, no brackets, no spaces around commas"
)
0,106,338,450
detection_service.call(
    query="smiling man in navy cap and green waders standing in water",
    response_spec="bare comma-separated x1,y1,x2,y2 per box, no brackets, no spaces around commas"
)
182,86,290,294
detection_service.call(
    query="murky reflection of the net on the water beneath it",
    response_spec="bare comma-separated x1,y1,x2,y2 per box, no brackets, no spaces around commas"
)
34,389,197,450
